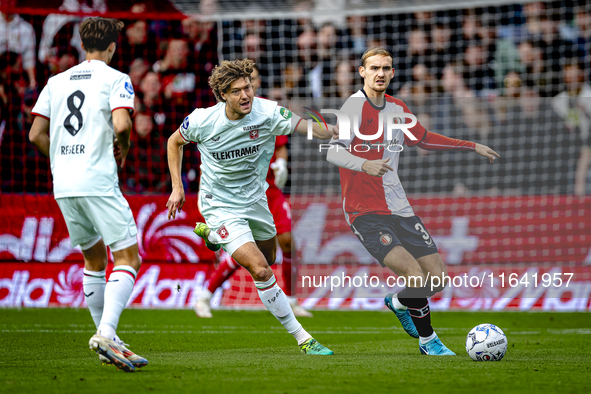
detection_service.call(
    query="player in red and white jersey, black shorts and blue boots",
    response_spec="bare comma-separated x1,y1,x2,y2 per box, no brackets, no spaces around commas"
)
327,47,500,355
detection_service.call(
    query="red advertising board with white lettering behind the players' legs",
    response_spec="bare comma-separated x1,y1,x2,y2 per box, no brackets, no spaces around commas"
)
0,195,591,311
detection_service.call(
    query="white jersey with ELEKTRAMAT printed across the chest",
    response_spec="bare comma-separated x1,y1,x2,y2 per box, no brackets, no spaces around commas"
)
179,97,293,207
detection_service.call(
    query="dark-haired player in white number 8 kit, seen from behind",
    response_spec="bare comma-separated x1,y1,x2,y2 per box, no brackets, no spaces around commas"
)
29,18,148,372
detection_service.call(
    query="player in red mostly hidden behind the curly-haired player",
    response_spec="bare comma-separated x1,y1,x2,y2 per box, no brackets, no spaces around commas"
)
194,67,312,318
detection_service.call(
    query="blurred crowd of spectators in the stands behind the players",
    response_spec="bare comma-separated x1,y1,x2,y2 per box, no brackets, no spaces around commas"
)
0,0,591,194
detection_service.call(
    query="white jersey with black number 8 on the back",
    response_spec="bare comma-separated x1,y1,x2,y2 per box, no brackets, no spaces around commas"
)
32,60,134,198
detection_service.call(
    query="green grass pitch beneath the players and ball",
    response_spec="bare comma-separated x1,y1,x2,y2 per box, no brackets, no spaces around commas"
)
0,309,591,394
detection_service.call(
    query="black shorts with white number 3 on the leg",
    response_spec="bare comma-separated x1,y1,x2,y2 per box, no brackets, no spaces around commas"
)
351,215,437,267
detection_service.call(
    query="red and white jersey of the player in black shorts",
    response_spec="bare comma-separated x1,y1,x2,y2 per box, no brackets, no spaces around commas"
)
331,90,426,223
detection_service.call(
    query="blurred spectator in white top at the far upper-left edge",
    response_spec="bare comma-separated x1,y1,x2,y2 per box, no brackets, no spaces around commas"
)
0,12,37,87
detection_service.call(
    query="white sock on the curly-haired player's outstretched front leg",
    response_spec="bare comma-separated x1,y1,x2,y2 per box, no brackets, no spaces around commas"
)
254,275,312,345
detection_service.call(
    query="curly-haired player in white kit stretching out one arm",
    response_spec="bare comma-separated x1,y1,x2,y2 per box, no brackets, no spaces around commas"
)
167,59,333,355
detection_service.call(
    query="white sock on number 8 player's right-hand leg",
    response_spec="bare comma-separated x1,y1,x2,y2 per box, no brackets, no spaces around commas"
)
99,265,137,339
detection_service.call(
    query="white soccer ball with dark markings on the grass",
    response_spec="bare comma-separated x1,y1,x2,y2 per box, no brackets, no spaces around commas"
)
466,324,507,361
